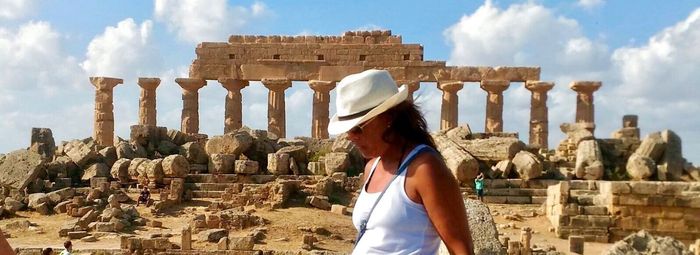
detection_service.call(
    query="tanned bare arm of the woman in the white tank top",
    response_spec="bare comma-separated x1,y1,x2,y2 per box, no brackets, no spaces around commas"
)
406,153,474,255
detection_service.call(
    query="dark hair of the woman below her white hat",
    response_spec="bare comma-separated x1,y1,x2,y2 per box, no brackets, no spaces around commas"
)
382,100,437,151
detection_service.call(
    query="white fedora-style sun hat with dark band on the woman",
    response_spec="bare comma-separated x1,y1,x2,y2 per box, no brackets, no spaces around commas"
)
328,69,408,135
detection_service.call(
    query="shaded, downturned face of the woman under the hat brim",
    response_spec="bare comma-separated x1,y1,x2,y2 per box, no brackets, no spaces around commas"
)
346,114,389,158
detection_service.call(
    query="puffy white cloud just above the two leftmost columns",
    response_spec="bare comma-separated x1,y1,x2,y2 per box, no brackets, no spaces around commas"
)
81,18,161,80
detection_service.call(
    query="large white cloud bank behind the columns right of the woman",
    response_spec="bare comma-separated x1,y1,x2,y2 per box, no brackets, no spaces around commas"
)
446,1,700,162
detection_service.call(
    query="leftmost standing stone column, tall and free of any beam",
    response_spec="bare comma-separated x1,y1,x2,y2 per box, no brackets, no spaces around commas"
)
90,77,124,146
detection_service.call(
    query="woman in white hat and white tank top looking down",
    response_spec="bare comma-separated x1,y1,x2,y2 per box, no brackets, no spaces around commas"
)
328,70,473,254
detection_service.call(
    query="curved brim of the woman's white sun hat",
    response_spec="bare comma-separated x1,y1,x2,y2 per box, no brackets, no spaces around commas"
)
328,84,408,135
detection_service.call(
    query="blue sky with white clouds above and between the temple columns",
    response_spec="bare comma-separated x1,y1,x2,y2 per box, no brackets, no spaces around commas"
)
0,0,700,165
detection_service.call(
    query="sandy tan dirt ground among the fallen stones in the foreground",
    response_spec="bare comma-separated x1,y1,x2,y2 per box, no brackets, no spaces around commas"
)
0,195,611,254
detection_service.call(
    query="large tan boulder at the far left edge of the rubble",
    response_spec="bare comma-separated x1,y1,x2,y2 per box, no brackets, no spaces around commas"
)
0,150,46,190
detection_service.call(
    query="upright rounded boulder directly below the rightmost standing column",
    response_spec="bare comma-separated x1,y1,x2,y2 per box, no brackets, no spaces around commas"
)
574,140,605,180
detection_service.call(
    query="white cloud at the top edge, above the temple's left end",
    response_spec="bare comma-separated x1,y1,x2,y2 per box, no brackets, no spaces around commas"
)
154,0,271,43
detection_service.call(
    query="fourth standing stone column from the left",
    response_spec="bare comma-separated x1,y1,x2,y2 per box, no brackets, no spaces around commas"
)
219,78,248,134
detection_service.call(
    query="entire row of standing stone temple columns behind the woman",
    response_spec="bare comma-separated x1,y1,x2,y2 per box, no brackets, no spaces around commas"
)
90,77,602,148
